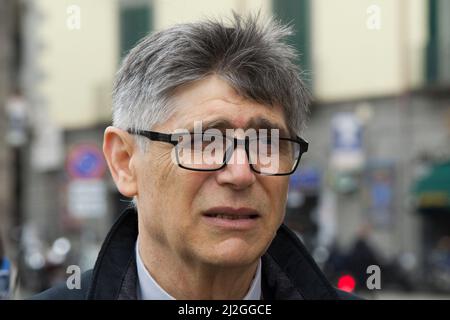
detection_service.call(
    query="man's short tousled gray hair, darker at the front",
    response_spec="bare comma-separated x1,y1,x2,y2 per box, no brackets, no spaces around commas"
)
113,12,309,149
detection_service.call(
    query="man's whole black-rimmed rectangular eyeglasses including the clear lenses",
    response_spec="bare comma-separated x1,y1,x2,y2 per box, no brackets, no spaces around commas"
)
127,129,308,176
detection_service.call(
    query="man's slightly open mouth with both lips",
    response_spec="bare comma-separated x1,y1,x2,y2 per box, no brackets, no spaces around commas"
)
203,207,261,230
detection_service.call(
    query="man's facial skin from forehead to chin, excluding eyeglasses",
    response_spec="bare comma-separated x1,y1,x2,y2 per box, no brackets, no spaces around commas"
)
135,77,289,266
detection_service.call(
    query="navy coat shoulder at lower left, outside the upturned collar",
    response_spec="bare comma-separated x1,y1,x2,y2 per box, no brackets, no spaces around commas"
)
30,270,92,300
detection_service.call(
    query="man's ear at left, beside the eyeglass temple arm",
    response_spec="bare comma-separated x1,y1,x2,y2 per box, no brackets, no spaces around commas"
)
103,127,137,198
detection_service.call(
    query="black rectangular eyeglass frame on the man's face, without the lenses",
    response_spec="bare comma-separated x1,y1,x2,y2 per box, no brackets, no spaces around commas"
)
127,129,309,176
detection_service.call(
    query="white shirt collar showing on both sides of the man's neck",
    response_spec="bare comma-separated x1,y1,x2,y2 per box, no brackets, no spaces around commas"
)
136,241,261,300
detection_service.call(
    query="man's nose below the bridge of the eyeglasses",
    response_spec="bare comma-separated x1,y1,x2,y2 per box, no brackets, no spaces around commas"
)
216,145,256,190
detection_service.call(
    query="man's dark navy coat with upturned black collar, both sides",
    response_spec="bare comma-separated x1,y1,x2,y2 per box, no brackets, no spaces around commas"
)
32,209,354,300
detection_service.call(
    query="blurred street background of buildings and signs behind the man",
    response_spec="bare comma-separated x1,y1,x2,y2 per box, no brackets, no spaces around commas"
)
0,0,450,299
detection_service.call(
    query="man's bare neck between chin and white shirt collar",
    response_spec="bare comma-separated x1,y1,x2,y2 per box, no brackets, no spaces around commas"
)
138,236,259,300
